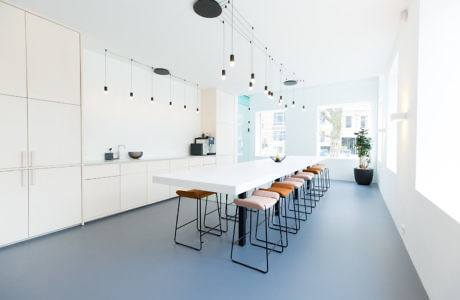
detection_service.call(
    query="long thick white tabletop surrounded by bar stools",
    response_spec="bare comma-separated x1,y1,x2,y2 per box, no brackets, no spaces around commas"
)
153,156,324,195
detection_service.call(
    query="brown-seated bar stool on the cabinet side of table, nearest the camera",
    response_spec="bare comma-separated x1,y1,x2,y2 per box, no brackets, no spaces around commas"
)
174,189,222,251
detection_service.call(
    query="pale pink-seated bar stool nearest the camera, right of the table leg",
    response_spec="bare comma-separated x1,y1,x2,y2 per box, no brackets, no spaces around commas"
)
230,196,282,273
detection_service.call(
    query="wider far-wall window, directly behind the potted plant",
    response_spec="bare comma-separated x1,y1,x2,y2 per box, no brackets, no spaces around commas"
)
318,103,371,157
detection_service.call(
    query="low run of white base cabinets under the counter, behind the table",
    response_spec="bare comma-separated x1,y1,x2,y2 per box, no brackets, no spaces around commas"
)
83,157,216,222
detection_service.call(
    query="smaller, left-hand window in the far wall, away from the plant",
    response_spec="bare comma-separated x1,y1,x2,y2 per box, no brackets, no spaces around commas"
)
256,111,286,156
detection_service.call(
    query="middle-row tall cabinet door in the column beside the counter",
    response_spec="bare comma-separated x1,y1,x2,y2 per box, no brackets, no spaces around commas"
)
29,99,81,167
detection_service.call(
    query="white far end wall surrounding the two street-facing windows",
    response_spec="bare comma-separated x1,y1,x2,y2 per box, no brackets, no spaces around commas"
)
250,78,379,181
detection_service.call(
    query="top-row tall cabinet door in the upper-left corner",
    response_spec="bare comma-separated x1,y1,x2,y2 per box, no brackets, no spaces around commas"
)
0,2,27,97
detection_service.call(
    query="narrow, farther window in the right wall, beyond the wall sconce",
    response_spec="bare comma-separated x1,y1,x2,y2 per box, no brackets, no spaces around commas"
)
386,55,399,173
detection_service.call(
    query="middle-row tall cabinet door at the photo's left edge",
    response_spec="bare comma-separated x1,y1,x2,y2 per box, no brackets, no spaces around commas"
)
0,95,27,169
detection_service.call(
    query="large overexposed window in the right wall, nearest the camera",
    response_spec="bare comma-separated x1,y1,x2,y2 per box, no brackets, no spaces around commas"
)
416,0,460,223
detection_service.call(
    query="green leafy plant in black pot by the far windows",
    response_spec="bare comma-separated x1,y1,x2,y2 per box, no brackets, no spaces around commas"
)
355,128,374,185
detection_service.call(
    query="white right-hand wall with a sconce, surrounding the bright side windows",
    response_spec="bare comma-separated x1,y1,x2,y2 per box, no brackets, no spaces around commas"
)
379,0,460,299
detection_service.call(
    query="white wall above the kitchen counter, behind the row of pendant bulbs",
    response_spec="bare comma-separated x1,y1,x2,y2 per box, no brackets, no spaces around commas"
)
82,44,201,161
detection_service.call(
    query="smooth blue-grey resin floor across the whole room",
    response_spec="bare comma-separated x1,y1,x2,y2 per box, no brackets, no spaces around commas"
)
0,181,428,300
